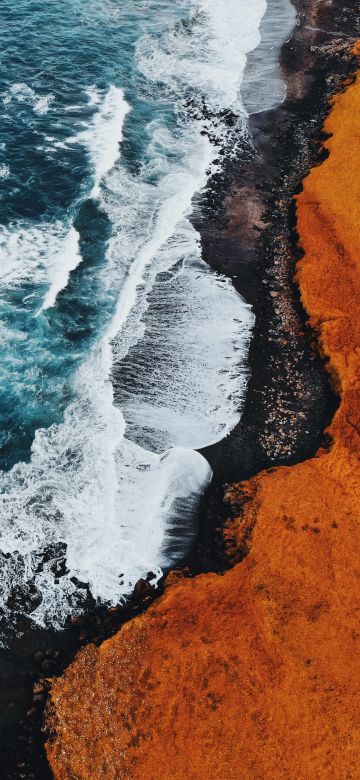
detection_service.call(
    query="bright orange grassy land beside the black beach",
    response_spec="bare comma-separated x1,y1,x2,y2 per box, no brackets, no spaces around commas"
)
47,64,360,780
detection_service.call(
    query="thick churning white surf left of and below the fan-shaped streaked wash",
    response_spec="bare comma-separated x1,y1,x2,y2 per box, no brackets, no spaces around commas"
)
0,114,219,625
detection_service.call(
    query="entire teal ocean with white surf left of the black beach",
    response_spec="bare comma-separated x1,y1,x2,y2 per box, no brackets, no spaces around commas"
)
0,0,294,629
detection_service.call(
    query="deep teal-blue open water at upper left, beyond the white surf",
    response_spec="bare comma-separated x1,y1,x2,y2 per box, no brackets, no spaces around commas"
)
0,0,184,469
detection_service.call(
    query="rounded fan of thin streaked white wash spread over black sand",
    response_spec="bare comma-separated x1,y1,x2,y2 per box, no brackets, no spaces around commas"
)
116,248,253,452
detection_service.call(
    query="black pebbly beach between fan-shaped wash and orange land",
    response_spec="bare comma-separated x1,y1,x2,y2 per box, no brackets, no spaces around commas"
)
189,0,356,571
